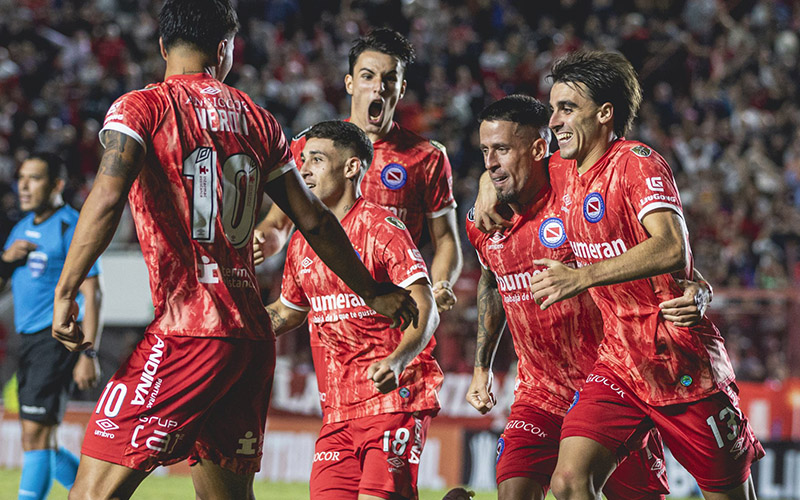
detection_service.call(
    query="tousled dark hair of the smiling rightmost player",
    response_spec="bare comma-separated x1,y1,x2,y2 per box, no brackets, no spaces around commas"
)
549,50,642,137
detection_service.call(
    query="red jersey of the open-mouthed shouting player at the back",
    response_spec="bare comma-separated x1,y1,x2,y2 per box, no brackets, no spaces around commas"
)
292,122,456,245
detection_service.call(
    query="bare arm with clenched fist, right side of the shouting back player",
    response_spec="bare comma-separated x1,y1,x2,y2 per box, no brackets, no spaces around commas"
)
428,210,463,312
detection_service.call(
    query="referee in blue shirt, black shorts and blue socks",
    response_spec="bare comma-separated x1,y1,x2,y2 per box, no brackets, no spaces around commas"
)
0,153,101,500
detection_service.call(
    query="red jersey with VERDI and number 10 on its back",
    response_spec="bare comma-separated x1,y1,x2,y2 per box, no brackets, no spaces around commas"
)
100,74,294,339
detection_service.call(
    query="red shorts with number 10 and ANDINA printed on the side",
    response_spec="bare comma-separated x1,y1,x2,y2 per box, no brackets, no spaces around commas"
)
81,333,275,474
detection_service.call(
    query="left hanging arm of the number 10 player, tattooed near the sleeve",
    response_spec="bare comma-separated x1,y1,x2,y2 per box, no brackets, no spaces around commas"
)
53,130,144,351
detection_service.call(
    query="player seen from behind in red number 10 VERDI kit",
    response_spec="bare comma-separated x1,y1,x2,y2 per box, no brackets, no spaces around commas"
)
53,0,417,499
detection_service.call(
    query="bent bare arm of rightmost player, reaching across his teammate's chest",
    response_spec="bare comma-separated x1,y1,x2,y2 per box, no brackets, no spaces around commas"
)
531,209,688,309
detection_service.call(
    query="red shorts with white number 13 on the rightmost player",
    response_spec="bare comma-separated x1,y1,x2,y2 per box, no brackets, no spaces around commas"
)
561,364,764,492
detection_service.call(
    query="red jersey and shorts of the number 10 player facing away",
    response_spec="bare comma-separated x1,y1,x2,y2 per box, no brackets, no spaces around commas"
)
82,73,294,473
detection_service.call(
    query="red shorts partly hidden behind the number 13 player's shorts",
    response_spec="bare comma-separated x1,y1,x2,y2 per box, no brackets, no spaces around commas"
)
497,403,669,500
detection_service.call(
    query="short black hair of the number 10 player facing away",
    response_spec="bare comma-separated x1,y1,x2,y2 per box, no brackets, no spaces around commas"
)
158,0,239,57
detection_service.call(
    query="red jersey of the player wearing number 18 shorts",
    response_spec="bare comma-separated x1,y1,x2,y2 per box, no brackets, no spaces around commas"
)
280,198,443,424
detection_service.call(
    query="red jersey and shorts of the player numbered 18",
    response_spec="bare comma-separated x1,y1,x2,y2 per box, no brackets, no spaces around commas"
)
280,197,443,499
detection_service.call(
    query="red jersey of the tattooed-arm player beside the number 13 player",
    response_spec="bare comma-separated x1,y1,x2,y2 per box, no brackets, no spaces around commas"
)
467,187,603,416
